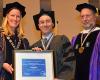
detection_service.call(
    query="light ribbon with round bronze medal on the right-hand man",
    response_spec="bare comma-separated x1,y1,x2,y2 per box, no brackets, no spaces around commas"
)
79,27,95,54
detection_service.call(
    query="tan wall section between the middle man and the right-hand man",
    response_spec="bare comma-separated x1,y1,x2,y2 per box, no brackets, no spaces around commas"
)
52,0,88,40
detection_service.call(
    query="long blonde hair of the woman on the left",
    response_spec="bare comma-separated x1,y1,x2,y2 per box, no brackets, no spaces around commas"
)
2,16,24,37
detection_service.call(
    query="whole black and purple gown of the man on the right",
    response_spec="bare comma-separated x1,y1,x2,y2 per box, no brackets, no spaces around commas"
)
72,29,100,80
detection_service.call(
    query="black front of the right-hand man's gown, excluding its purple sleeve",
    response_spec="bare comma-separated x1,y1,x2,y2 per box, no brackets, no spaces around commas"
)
74,30,100,80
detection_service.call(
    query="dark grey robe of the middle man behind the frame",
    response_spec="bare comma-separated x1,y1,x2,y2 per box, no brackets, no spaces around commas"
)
31,35,75,80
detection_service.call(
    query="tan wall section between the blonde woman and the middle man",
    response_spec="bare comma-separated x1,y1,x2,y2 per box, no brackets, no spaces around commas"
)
3,0,40,45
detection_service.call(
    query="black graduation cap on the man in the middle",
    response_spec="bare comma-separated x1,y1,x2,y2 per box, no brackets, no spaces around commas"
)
33,9,55,30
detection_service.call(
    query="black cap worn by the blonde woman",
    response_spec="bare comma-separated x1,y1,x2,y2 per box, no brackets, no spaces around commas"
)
3,2,26,17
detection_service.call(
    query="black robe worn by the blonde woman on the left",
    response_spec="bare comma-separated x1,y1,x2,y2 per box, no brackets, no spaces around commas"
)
0,36,29,80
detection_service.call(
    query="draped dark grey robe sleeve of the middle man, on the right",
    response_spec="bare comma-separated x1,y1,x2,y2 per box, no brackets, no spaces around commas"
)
58,35,75,80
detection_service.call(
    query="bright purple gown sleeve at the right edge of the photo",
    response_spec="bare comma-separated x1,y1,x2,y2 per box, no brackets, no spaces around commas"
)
89,32,100,80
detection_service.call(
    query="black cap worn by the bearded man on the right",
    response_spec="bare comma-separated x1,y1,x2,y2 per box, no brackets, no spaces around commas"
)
76,3,97,13
